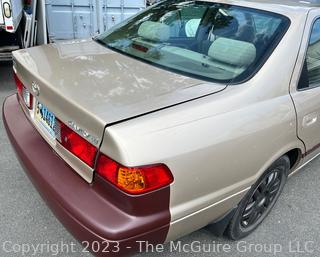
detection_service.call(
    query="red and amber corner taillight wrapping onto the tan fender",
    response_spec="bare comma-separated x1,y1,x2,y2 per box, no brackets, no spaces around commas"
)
97,154,173,194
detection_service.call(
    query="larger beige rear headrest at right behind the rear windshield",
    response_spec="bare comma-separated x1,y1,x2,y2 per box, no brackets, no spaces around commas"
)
208,37,257,67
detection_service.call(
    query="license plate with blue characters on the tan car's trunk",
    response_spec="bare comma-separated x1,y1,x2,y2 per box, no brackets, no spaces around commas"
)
35,102,56,138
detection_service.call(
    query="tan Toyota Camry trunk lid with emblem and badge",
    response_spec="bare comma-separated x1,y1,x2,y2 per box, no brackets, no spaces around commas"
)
13,40,226,182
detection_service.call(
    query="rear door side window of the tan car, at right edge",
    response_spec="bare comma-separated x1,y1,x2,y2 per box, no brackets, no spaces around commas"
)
299,19,320,89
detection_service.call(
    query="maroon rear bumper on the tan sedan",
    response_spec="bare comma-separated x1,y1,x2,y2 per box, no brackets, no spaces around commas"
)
3,95,170,256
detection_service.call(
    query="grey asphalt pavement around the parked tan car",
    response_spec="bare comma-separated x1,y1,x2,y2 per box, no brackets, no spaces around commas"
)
0,64,320,257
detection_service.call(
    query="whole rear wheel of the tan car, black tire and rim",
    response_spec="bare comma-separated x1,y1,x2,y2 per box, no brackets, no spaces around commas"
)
225,156,290,240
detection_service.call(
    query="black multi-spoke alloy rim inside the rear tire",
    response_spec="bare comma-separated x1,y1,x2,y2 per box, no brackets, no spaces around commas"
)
240,169,283,229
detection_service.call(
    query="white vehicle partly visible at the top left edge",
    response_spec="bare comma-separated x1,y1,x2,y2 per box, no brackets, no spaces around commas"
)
0,0,23,61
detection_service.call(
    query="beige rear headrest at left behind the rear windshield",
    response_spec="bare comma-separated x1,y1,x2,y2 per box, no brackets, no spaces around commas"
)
138,21,170,42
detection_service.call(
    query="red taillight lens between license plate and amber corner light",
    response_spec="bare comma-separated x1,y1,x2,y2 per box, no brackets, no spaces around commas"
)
56,120,97,168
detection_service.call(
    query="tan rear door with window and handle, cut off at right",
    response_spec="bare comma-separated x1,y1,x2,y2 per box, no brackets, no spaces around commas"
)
291,10,320,160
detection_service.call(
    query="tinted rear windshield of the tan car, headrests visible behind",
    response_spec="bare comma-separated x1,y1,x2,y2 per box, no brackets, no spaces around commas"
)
96,0,290,84
